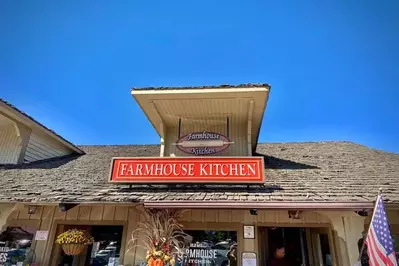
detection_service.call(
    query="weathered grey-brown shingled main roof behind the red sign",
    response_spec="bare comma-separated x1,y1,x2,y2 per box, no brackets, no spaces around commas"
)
0,142,399,203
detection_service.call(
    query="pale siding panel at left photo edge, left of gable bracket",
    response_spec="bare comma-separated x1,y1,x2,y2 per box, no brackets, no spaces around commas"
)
0,125,21,164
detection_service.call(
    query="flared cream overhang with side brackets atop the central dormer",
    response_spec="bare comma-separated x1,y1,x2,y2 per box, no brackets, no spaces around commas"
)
131,84,270,151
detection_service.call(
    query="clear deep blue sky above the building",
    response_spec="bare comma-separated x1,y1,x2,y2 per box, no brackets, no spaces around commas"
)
0,0,399,152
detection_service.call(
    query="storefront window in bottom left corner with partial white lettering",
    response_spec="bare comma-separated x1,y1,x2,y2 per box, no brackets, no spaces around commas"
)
0,227,35,266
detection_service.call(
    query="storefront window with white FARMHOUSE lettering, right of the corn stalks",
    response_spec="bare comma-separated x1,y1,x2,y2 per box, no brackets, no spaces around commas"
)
179,230,237,266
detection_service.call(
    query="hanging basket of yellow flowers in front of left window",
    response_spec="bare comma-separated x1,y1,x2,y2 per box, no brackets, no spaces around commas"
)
55,229,94,256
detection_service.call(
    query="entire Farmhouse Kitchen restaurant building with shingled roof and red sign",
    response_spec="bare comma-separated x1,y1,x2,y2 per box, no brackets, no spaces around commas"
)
0,84,399,266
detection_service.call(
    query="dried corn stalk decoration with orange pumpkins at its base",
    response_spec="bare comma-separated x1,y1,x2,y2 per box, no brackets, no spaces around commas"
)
128,209,191,266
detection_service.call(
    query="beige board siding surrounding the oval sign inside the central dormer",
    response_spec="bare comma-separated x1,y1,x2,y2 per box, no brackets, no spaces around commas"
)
156,98,252,157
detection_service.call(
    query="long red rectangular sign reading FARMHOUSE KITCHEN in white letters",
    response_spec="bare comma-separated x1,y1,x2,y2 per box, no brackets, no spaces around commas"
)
110,157,265,184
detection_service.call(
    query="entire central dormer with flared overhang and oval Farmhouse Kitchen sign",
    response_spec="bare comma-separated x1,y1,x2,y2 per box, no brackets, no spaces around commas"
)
131,84,270,157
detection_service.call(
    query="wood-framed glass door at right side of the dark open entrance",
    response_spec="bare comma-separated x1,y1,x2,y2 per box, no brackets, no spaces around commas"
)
308,228,336,266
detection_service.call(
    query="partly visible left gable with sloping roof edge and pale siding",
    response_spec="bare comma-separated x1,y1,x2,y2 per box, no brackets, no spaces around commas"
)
0,99,83,165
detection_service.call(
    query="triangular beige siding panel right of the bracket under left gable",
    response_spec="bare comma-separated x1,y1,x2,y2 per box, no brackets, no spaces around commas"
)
24,132,71,162
